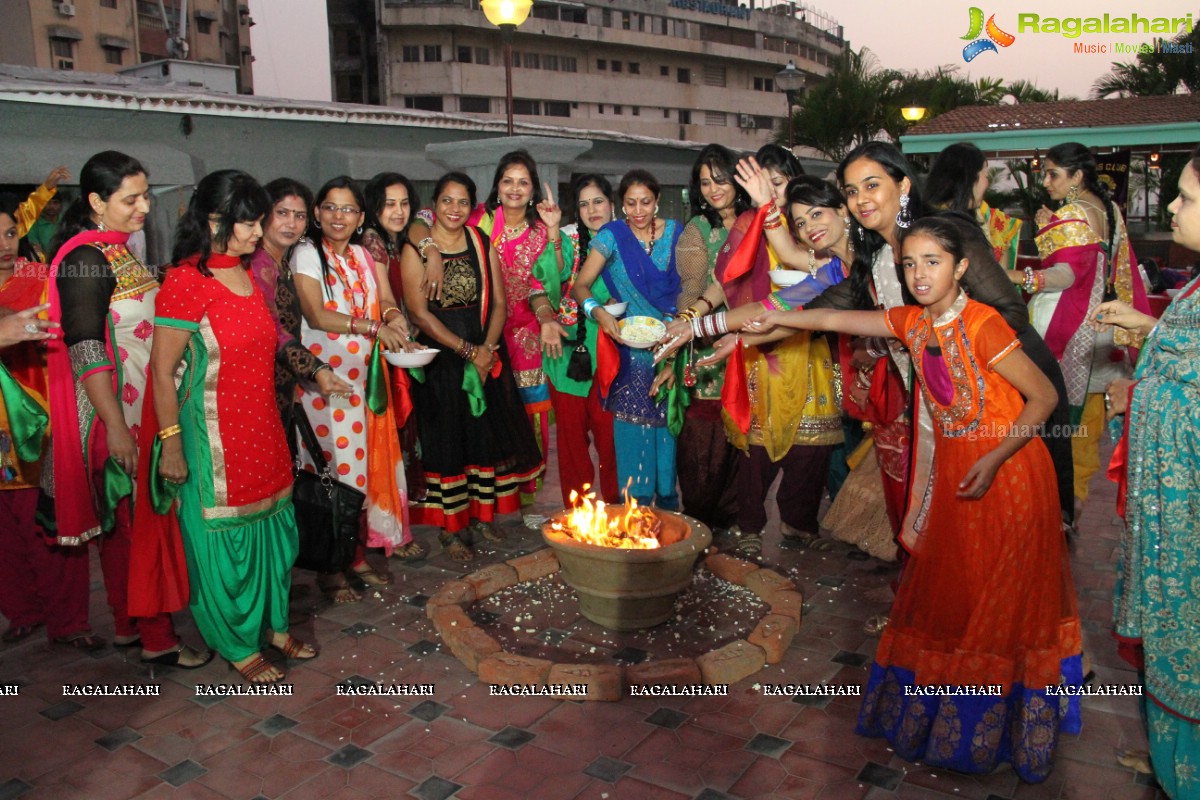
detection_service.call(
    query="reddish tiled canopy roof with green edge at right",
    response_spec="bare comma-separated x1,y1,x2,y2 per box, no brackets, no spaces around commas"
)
900,95,1200,156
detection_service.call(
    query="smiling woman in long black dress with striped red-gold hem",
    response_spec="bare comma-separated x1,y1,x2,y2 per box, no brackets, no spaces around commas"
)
401,173,545,561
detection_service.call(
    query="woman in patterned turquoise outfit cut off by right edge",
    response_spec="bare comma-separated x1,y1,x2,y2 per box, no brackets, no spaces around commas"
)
1091,148,1200,800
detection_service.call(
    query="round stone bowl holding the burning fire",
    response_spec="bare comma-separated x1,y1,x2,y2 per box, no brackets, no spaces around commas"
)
541,507,713,631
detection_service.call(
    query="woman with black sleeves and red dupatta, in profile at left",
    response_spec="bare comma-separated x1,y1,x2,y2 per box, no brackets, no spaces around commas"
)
38,150,212,669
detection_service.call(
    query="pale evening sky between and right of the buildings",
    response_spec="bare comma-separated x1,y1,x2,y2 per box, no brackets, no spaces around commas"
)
250,0,1198,100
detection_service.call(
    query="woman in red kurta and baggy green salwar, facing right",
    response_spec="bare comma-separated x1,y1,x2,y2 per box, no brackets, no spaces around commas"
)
146,169,317,684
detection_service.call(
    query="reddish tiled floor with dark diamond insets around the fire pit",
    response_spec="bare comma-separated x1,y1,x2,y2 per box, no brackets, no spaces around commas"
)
0,441,1159,800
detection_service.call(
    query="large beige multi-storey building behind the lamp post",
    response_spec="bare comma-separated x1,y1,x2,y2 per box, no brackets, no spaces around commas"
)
329,0,846,149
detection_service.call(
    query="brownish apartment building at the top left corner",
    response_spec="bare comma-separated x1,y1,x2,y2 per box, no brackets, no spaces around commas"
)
0,0,253,94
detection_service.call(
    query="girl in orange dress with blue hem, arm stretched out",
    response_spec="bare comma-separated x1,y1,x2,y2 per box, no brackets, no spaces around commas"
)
749,217,1082,783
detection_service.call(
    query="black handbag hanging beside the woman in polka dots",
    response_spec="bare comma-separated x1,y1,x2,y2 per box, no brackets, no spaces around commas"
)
292,403,367,572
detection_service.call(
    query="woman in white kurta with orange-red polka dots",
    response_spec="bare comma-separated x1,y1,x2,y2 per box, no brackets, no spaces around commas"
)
292,176,424,602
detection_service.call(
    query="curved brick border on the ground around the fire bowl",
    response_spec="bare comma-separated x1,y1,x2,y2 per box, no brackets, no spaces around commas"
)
425,547,804,700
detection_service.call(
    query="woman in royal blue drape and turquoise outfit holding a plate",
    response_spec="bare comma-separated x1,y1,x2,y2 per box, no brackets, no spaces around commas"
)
572,169,683,510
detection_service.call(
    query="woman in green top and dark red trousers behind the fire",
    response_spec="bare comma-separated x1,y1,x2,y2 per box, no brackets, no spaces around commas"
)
529,174,620,506
